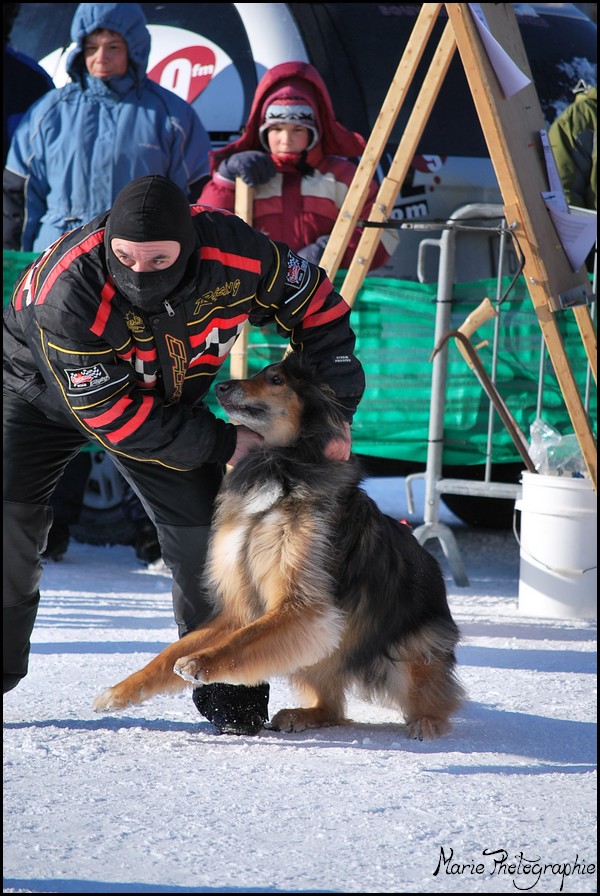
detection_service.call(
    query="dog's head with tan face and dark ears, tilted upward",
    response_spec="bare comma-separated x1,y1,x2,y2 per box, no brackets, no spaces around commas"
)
215,353,344,453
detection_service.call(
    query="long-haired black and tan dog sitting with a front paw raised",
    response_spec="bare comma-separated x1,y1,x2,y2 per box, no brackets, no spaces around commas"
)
94,354,464,738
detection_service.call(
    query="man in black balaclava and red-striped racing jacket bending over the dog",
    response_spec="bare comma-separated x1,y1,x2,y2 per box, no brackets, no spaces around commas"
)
3,175,365,734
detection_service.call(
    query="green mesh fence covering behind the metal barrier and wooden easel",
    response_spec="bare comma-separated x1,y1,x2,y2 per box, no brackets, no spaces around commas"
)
4,251,597,465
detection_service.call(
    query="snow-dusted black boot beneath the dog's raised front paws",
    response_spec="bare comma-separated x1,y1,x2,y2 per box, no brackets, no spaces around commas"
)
192,682,269,734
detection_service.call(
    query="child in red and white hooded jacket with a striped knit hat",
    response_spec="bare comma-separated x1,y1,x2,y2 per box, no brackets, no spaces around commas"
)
198,62,397,268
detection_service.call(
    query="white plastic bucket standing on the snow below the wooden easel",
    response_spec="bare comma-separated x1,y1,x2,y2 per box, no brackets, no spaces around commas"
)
515,471,598,619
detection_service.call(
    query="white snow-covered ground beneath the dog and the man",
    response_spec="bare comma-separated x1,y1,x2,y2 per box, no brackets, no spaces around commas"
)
4,479,597,893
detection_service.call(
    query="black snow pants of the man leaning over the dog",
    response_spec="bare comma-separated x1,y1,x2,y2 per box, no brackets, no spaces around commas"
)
3,392,224,692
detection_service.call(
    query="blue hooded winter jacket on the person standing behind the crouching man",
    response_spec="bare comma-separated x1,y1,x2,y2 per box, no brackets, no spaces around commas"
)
3,3,210,252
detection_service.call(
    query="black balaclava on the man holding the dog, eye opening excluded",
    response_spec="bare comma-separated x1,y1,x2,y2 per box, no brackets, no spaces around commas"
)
104,174,198,312
